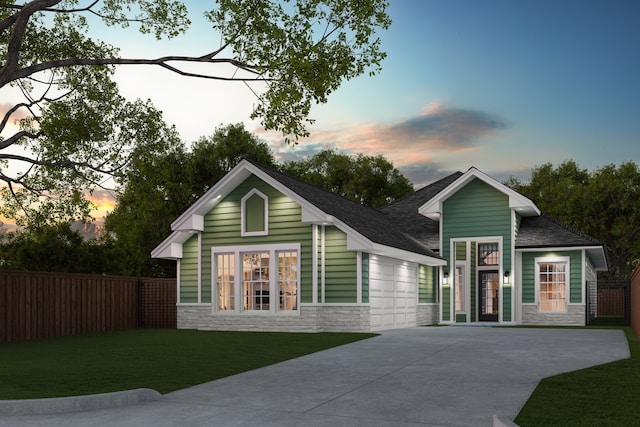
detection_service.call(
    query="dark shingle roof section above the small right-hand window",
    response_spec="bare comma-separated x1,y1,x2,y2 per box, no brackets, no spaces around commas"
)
516,214,602,249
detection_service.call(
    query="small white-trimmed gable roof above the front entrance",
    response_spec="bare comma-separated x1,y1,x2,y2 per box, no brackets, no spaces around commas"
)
418,167,540,220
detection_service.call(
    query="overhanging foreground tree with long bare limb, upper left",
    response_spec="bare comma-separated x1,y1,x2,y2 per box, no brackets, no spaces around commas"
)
0,0,390,227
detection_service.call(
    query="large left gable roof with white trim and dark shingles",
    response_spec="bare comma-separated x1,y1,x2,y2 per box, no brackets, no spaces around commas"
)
152,159,445,265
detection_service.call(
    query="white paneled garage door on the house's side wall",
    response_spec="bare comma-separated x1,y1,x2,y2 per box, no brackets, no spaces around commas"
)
369,255,418,330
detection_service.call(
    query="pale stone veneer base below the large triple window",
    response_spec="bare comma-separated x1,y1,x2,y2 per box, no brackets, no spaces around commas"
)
178,304,370,332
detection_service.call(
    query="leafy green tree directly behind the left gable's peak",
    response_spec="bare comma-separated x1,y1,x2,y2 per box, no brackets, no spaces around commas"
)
105,124,275,276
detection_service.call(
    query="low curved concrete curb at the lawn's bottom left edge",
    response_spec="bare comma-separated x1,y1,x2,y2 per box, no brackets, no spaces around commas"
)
0,388,162,416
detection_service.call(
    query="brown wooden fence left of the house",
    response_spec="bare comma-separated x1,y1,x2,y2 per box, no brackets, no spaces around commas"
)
0,270,176,342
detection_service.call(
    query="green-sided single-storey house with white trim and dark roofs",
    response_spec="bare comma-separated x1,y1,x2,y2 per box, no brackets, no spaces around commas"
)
152,160,607,332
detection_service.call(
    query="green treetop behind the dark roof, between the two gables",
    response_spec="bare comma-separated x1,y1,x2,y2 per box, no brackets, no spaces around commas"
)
282,150,413,207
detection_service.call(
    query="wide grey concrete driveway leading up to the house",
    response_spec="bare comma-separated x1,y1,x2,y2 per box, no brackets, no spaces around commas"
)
0,326,629,427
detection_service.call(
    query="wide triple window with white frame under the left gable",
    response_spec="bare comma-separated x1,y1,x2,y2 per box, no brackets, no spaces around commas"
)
212,244,300,313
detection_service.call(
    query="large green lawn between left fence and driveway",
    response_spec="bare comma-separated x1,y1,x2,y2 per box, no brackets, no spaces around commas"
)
0,329,375,399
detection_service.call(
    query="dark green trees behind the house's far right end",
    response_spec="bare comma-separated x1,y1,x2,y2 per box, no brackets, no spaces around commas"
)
506,161,640,279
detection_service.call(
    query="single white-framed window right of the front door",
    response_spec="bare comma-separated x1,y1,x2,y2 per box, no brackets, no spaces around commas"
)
536,257,569,312
